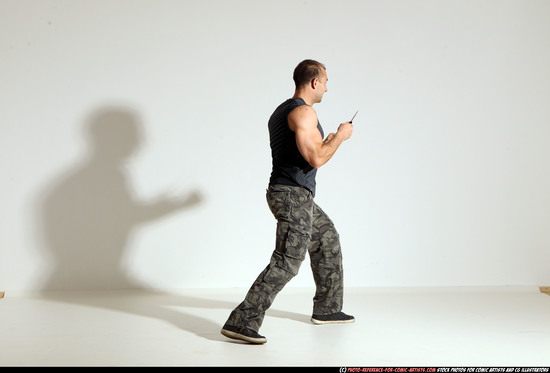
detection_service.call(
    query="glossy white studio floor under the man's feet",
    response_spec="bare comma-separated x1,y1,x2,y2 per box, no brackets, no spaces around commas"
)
0,288,550,367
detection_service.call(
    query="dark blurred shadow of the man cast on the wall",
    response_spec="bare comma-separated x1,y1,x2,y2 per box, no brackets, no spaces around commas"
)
41,107,201,290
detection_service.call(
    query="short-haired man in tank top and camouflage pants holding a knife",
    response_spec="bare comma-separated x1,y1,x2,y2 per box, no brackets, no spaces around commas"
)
221,60,355,344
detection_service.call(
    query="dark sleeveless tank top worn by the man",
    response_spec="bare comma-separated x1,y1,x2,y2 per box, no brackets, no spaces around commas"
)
268,98,324,195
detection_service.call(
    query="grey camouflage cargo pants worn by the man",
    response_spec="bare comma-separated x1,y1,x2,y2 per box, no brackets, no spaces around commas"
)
226,185,343,331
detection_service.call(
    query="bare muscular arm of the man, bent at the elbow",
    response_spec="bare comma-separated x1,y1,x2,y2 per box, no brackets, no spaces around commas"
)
288,105,353,168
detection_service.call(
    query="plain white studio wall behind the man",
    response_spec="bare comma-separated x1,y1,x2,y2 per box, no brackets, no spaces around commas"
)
0,0,550,290
